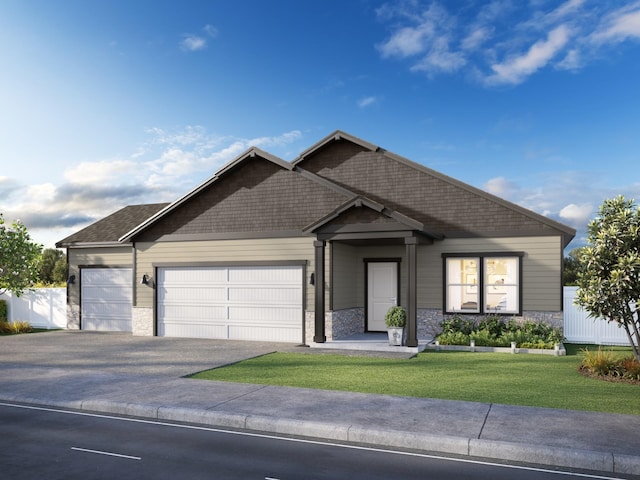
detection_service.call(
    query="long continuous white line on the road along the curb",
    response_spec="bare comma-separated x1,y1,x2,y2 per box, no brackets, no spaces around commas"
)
0,402,624,480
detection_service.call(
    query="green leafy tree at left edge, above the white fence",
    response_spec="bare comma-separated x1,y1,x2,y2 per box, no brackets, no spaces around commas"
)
0,214,42,296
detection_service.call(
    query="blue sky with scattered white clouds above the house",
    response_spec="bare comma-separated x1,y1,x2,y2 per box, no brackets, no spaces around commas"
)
0,0,640,251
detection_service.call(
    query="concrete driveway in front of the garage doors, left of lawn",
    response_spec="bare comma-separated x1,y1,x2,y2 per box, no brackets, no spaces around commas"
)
0,330,300,377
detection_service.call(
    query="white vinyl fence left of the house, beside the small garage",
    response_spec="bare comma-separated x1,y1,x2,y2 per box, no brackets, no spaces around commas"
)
0,288,67,328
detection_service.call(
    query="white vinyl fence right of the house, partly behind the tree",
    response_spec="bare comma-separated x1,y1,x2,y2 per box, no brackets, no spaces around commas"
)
564,287,629,345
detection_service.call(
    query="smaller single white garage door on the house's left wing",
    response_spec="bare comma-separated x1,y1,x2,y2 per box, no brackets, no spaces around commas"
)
80,268,133,332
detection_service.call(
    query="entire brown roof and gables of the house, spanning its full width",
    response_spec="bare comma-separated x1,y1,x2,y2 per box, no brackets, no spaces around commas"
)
59,130,575,246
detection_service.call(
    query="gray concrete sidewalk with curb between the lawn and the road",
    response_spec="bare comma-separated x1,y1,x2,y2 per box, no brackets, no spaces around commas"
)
0,366,640,475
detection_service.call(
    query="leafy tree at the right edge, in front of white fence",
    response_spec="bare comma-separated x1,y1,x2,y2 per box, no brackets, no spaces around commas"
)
576,196,640,361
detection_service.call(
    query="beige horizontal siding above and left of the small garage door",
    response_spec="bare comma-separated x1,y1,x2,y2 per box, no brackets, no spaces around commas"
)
67,245,133,305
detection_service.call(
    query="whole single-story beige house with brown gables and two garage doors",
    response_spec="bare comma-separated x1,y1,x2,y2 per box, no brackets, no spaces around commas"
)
57,131,575,346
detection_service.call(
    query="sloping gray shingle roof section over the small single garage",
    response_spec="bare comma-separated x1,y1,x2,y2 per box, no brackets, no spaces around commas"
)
56,203,169,248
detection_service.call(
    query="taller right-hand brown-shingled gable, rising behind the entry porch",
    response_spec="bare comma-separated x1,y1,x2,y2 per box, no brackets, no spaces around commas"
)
292,130,576,246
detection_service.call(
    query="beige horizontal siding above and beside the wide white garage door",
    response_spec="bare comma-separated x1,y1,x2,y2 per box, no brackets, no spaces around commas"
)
136,237,316,309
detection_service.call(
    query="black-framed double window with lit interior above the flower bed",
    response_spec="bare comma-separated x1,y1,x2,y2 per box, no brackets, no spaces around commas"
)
443,253,522,314
